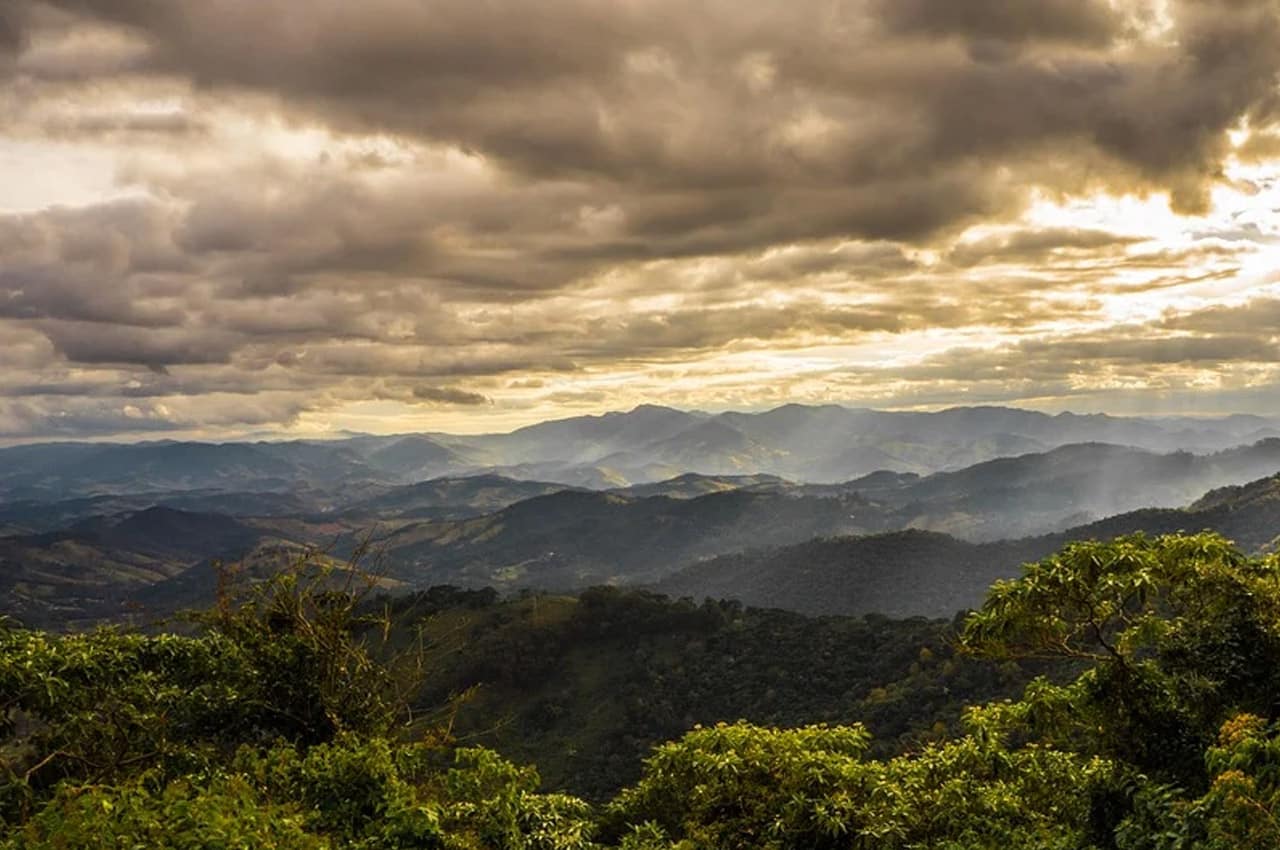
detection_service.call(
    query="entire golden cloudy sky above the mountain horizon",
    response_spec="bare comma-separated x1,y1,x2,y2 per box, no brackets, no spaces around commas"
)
0,0,1280,440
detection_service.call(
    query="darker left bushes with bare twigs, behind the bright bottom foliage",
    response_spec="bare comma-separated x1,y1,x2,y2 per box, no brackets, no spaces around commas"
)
0,560,401,806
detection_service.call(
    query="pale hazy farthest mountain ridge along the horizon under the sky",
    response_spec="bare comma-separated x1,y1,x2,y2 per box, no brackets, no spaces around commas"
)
0,405,1280,501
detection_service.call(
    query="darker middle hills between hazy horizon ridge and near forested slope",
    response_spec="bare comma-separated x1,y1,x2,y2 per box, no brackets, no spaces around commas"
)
0,465,1280,625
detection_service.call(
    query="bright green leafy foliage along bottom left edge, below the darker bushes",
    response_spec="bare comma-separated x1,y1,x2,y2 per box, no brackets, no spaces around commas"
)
0,734,593,850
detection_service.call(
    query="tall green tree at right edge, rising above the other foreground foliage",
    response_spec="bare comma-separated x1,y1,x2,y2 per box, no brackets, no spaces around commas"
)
964,534,1280,787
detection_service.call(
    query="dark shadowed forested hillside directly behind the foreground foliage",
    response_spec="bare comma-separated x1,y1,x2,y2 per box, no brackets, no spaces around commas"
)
392,588,1061,799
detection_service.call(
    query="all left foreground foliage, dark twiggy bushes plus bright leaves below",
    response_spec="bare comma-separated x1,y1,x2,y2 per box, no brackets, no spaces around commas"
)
0,563,593,850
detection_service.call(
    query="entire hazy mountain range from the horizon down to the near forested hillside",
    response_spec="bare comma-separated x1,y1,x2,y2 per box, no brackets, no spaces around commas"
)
0,406,1280,623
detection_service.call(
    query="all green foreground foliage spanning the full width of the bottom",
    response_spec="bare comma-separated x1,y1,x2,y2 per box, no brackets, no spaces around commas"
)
0,535,1280,850
